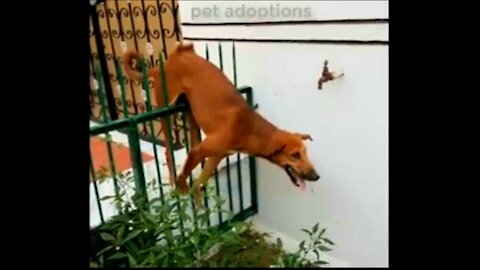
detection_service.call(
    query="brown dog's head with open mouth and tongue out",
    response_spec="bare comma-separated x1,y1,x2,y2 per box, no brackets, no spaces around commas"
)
265,132,320,190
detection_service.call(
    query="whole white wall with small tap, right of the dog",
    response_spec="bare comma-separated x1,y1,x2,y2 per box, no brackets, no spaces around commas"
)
180,1,389,267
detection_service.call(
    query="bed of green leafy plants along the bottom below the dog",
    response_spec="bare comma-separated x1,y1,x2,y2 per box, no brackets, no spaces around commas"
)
90,170,333,268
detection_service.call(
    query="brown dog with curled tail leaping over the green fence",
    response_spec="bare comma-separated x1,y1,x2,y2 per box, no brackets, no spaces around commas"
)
123,41,320,205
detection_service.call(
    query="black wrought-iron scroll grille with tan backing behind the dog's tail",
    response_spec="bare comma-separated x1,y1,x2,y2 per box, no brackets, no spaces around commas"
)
90,0,184,149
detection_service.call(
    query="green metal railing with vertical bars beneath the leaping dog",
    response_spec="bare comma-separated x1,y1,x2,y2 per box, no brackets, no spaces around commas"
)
90,44,258,229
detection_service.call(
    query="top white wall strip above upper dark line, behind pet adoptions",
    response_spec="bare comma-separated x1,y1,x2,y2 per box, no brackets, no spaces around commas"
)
179,0,388,22
